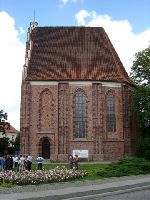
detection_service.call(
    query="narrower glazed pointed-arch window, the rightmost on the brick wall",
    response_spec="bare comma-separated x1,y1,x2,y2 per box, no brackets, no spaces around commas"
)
107,90,116,132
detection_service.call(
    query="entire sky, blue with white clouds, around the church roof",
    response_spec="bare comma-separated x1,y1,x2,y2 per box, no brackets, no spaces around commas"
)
0,0,150,130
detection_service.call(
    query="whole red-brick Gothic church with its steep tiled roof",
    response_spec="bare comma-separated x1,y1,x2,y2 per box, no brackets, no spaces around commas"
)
20,22,137,161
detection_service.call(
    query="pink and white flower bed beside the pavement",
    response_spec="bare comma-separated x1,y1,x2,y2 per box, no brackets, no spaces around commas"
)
0,167,87,185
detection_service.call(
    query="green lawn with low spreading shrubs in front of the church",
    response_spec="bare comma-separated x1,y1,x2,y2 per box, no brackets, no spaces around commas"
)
33,157,150,180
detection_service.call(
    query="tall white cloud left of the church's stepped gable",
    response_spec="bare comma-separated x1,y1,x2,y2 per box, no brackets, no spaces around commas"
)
0,11,25,129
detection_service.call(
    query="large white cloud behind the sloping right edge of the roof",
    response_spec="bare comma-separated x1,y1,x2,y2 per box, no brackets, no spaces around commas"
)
75,10,150,73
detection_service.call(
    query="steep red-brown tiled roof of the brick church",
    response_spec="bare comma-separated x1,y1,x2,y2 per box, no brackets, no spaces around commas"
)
26,27,131,84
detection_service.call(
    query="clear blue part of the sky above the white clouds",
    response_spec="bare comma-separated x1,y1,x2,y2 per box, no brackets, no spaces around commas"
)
0,0,150,36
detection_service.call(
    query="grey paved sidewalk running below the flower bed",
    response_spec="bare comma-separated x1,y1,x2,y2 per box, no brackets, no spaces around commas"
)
0,175,150,200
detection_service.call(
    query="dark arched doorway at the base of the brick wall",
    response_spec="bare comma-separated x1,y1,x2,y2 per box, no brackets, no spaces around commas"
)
42,138,50,159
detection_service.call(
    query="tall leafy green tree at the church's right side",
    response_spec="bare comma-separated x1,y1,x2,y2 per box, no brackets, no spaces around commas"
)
130,47,150,137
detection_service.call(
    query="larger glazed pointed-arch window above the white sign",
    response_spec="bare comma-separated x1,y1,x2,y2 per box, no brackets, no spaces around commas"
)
73,90,86,138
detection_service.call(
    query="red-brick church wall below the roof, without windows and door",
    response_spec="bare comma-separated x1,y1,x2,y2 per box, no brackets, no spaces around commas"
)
21,82,138,161
